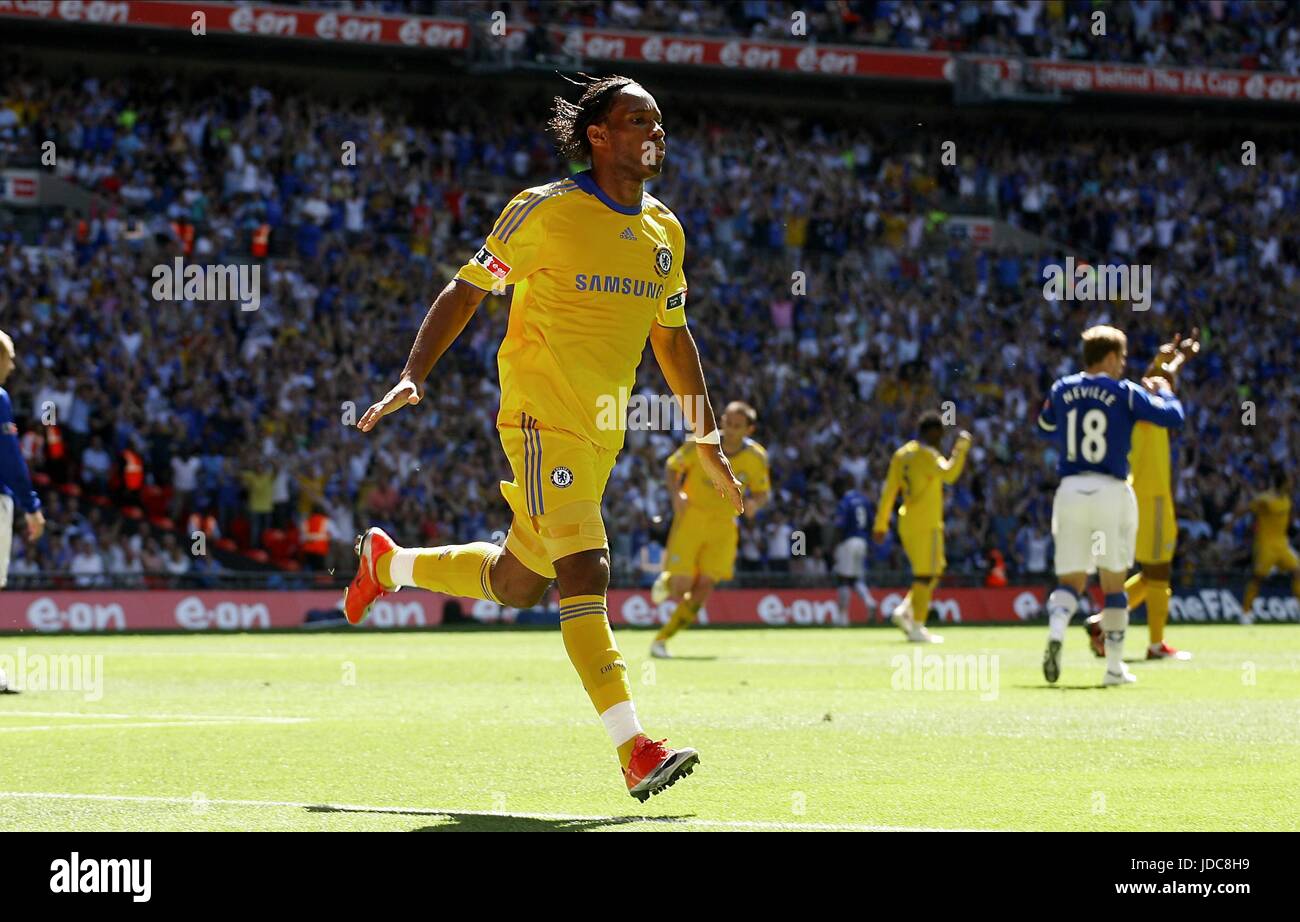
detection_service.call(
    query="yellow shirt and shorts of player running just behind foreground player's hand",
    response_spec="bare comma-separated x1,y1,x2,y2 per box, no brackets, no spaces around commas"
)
664,438,772,583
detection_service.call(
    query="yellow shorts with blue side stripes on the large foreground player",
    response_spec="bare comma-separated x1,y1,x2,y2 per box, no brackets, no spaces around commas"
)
497,414,618,579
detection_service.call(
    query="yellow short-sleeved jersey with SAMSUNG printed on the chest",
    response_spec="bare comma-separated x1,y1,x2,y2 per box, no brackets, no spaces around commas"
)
456,172,686,451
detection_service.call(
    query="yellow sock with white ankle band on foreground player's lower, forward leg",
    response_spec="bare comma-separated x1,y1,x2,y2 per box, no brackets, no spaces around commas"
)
560,596,642,769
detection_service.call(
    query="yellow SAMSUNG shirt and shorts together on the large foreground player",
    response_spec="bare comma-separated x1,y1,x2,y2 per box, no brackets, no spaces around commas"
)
456,172,686,577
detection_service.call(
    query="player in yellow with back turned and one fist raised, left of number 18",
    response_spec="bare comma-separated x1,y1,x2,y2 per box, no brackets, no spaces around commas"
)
872,410,971,644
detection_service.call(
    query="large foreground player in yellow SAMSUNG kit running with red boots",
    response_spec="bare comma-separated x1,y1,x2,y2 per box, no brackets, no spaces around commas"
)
343,77,744,801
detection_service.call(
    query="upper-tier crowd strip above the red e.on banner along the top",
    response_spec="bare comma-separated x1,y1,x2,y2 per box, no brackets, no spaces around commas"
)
343,0,1300,74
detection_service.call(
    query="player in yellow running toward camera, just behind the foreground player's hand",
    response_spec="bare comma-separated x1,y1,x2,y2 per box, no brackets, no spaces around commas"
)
650,401,771,659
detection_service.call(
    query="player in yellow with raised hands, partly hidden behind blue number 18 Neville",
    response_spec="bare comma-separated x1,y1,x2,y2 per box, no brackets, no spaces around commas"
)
1084,329,1201,659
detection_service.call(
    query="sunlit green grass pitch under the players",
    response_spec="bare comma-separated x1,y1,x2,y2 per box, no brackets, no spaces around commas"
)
0,626,1300,831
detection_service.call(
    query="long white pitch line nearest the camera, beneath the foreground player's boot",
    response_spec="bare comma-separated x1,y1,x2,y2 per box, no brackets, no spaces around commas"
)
0,791,977,832
